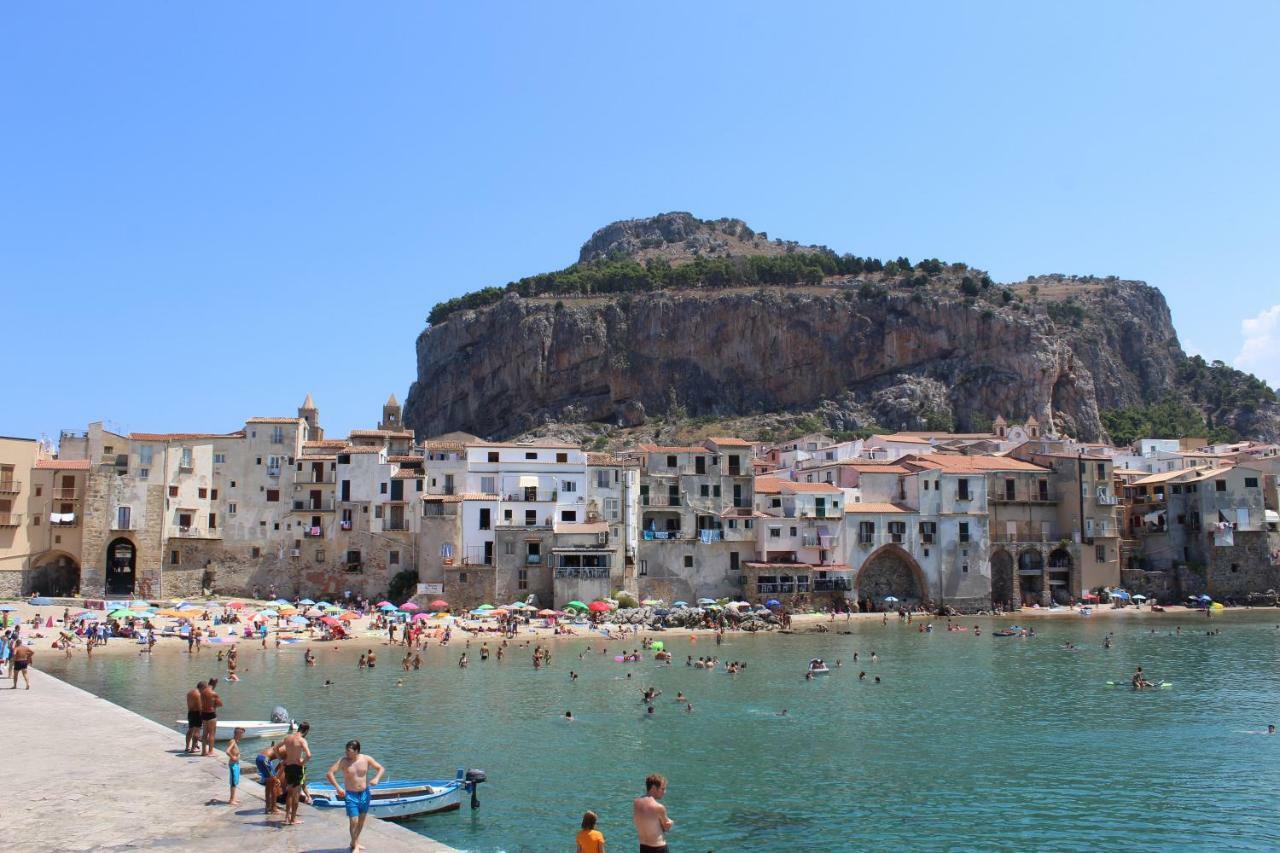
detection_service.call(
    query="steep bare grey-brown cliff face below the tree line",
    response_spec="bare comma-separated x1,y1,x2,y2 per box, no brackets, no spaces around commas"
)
404,277,1228,439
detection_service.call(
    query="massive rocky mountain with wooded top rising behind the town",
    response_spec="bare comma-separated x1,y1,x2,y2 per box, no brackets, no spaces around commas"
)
404,214,1280,441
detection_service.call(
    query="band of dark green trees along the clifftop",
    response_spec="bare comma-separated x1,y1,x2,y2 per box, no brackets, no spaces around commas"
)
426,250,962,325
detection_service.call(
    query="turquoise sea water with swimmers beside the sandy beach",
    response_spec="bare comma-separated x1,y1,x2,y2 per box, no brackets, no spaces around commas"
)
40,611,1280,852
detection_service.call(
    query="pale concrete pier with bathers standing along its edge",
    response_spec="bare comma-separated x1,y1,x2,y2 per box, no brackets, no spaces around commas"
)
0,671,452,853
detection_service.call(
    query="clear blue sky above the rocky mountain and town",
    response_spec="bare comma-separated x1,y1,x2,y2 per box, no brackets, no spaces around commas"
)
0,1,1280,445
